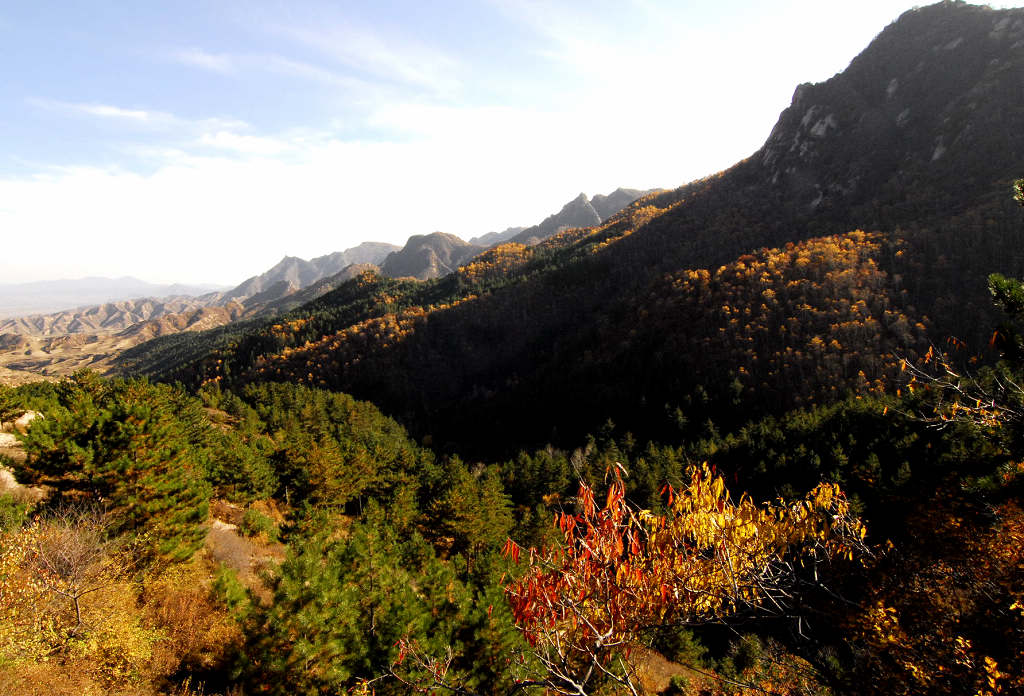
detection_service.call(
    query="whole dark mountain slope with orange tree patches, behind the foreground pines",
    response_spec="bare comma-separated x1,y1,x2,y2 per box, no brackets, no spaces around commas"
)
123,3,1024,454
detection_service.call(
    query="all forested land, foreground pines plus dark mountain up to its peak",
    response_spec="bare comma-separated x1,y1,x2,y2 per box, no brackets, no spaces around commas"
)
6,3,1024,696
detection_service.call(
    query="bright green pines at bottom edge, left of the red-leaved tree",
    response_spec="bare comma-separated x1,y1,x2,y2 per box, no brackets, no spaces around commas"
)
249,505,472,694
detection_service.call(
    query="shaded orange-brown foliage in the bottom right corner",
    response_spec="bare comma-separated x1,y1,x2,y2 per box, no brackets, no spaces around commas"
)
846,492,1024,696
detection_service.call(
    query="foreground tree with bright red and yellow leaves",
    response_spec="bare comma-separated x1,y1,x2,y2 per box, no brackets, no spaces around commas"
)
505,465,866,694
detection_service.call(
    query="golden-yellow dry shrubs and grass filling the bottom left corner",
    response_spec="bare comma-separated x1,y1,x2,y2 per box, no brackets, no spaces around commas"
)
0,510,243,696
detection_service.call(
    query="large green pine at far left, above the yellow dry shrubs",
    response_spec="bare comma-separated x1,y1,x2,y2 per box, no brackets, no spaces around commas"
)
17,373,210,561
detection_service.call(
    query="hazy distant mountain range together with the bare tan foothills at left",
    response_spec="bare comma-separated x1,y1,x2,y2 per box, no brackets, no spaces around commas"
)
0,188,642,382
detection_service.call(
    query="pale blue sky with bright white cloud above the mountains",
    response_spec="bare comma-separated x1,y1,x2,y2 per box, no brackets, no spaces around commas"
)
0,0,974,286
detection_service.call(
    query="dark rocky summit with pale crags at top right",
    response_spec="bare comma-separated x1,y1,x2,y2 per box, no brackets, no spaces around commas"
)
753,3,1024,210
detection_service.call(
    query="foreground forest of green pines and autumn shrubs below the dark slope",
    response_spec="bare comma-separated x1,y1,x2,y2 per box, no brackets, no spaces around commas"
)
0,264,1024,695
